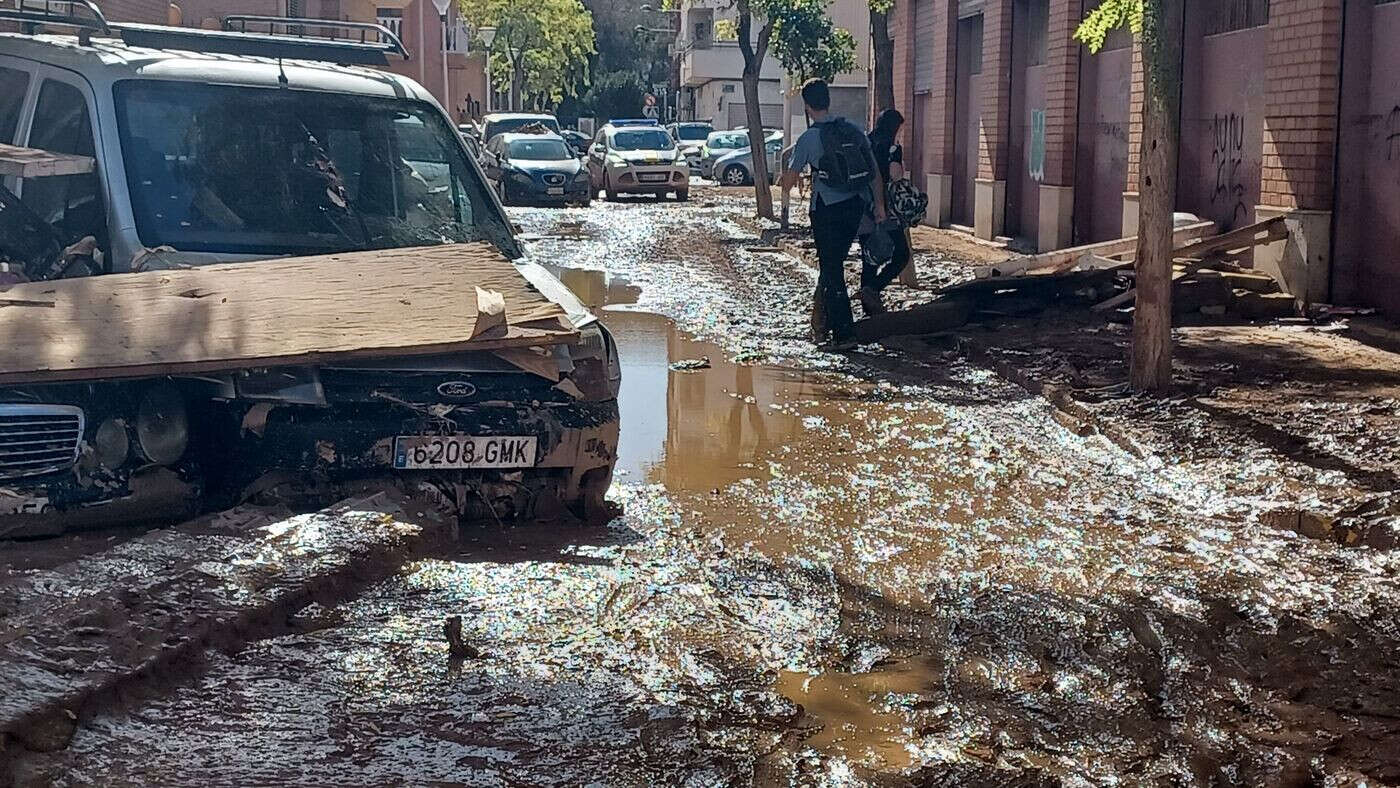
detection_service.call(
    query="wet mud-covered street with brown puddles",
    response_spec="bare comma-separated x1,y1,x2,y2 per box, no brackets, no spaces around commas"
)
10,189,1400,785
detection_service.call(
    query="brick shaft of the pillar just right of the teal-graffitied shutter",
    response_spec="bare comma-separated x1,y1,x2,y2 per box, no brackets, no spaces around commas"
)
1044,0,1081,186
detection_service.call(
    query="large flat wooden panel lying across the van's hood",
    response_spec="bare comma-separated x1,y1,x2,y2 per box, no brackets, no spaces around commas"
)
0,244,577,384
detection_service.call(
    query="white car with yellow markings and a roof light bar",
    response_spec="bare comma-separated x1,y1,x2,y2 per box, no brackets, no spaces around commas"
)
588,120,690,200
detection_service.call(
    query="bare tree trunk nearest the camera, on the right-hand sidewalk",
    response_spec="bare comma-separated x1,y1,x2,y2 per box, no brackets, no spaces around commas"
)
1128,0,1183,392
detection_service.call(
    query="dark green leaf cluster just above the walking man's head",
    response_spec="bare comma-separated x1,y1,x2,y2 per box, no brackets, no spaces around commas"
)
756,0,855,84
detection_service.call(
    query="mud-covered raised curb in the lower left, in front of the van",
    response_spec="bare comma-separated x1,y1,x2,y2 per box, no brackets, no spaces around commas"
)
0,493,440,784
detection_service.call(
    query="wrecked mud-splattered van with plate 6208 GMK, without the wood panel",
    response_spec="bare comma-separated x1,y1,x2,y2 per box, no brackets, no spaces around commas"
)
0,17,620,535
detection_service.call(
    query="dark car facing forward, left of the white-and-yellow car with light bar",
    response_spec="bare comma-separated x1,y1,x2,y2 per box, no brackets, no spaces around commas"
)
482,133,594,206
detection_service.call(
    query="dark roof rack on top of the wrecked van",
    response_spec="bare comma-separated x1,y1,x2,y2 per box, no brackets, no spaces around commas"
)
0,0,409,66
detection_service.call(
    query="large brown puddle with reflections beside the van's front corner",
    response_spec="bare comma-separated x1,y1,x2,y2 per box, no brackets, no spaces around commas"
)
554,269,823,491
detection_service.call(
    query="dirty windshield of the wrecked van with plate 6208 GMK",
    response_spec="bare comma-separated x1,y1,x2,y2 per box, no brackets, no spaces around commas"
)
116,80,512,255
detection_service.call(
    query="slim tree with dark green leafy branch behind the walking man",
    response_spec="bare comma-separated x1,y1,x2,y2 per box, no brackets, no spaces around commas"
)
735,0,855,218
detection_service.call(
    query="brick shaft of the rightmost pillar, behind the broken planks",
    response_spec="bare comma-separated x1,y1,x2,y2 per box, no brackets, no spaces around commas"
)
1260,0,1343,210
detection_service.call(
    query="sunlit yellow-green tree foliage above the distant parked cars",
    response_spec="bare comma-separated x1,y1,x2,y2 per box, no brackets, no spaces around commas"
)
459,0,595,109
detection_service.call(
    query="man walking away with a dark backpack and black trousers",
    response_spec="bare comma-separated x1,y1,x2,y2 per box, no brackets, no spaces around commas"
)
780,80,885,350
